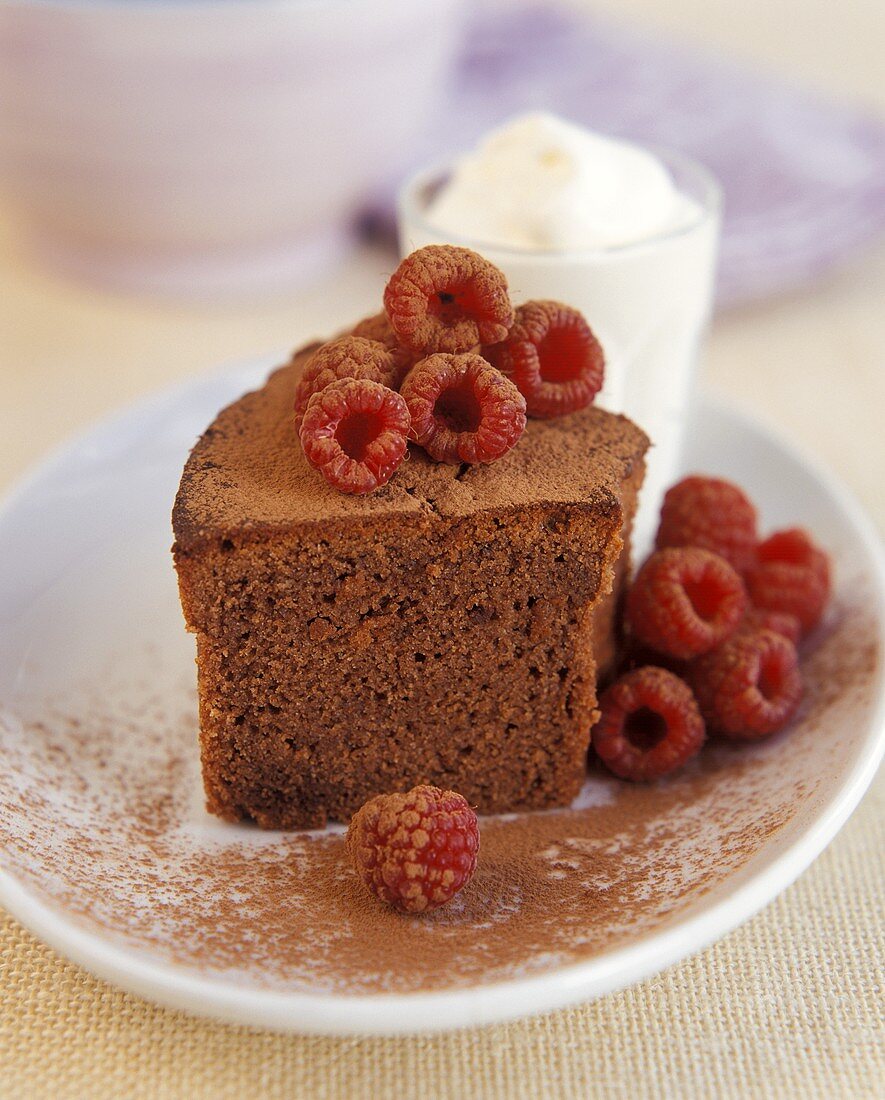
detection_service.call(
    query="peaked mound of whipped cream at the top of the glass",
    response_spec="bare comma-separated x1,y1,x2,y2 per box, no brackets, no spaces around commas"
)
425,111,698,251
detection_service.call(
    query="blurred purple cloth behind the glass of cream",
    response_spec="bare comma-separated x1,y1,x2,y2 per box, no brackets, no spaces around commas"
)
362,7,885,306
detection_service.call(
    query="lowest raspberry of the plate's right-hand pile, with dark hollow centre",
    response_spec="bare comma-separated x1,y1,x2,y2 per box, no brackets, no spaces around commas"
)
593,664,705,780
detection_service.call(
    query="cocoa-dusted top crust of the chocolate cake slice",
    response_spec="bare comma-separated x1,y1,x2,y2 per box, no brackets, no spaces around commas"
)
173,344,649,551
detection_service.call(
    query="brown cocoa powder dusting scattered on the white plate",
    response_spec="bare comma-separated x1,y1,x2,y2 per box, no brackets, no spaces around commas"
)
0,602,880,993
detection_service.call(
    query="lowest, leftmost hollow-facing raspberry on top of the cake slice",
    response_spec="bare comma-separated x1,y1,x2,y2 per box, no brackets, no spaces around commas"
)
301,378,409,493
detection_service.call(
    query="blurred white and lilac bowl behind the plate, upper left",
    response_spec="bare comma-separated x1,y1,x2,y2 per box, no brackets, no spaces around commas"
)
0,0,462,294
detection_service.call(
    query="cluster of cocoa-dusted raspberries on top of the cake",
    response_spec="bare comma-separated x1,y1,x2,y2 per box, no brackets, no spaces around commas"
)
295,245,605,493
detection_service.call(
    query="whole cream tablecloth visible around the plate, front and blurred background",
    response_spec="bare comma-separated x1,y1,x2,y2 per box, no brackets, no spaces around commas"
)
0,0,885,1098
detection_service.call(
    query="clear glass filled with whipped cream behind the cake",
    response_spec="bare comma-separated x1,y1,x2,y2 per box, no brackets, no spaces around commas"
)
399,113,720,553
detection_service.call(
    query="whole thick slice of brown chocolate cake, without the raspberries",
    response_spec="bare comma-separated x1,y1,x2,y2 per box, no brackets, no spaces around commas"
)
173,349,648,828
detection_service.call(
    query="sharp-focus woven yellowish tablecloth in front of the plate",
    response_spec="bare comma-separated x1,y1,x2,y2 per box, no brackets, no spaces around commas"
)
0,774,885,1100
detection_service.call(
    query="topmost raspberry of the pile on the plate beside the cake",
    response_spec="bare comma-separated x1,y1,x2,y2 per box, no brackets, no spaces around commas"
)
655,475,756,573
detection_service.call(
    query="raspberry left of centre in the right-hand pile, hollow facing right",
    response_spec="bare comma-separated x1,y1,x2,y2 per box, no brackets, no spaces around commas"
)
627,547,746,660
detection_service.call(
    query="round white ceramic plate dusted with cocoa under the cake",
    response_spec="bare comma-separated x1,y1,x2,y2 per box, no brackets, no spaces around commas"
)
0,361,885,1034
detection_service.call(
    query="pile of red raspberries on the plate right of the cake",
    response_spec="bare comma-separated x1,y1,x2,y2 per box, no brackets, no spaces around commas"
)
591,476,830,780
